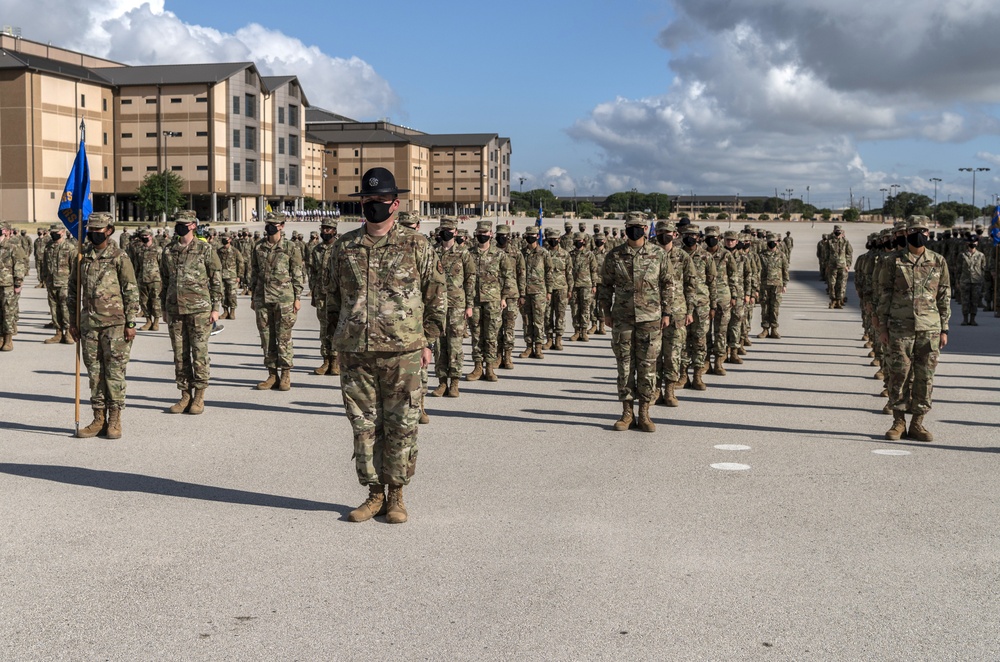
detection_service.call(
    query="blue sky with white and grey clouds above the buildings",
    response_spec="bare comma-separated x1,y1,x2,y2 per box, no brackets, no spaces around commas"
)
0,0,1000,207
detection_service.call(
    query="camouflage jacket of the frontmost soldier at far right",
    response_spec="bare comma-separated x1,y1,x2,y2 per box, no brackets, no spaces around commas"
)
878,248,951,334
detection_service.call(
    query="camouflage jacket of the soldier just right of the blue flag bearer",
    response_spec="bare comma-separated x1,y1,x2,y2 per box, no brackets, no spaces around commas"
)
160,239,222,316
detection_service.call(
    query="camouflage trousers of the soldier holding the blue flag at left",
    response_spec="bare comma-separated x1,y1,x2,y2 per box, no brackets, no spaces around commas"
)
80,326,132,409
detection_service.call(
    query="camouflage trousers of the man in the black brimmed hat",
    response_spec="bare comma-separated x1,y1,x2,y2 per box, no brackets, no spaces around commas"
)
340,351,423,485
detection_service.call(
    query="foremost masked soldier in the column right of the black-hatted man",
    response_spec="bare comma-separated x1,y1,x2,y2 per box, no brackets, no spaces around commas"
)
600,213,674,432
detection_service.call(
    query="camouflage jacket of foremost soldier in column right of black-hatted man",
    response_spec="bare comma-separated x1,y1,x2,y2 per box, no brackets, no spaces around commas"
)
598,241,674,324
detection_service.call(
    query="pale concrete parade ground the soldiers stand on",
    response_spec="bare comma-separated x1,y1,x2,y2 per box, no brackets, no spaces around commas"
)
0,220,1000,661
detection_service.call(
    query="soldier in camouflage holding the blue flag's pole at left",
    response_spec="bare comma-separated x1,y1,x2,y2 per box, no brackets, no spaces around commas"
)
69,212,139,439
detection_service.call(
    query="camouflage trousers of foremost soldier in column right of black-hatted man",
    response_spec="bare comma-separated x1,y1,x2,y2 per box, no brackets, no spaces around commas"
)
611,320,663,402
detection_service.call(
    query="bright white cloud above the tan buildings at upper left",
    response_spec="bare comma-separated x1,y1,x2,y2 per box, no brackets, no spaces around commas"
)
0,0,400,119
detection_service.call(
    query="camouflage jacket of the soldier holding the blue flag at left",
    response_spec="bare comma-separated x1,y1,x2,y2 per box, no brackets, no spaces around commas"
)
69,241,139,332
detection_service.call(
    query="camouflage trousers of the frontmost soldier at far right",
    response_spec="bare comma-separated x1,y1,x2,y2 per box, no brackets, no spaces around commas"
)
887,329,941,414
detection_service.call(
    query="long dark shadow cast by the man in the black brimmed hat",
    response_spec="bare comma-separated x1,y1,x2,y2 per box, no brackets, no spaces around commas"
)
0,463,351,515
